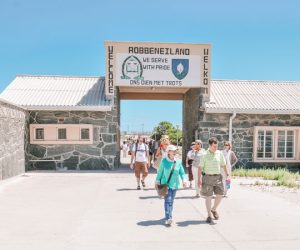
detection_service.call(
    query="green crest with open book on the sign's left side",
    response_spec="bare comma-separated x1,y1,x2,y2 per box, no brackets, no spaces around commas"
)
121,56,144,80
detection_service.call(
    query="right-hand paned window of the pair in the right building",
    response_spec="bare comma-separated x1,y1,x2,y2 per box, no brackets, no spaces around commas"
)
277,130,295,158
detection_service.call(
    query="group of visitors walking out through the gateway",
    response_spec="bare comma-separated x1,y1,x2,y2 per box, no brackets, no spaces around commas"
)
130,136,237,226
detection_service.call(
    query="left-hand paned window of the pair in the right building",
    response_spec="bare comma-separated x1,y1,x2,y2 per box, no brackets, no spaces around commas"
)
257,130,273,158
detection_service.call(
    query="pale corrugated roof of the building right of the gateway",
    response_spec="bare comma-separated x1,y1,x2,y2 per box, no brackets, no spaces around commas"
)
205,80,300,114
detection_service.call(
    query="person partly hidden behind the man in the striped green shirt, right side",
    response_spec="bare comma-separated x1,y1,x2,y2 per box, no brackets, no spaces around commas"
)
221,141,238,197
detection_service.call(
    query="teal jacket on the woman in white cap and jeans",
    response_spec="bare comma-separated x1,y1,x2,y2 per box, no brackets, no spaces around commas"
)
156,158,185,189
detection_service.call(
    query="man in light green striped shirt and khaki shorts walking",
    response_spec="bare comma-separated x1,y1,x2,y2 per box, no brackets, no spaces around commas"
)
198,137,229,223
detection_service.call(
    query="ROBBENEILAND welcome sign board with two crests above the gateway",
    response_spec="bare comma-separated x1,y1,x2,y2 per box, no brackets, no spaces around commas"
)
106,42,210,95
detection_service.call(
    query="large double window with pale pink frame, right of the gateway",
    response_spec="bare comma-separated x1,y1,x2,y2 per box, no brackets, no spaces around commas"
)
253,126,300,162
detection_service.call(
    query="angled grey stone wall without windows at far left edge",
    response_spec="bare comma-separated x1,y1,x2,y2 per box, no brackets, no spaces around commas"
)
0,100,27,180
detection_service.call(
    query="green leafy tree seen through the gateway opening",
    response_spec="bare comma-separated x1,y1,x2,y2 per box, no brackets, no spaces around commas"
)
151,121,182,145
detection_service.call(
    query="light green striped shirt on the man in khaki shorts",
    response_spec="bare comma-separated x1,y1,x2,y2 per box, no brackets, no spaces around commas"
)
200,150,226,174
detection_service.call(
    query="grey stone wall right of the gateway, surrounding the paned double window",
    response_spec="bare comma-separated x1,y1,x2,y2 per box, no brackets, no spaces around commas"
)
197,111,300,170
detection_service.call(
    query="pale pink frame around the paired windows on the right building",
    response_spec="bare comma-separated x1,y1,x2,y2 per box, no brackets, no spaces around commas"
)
253,126,300,163
